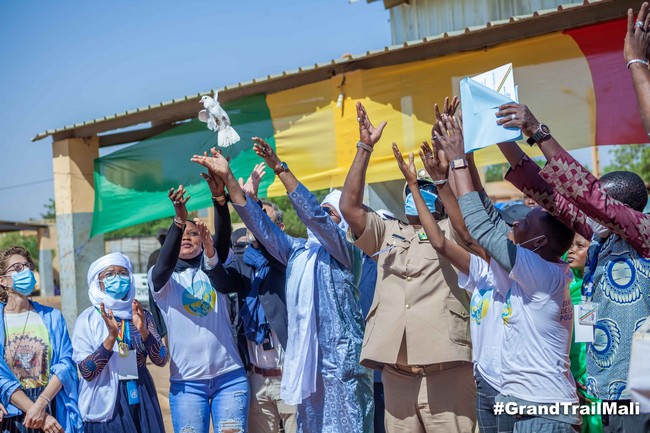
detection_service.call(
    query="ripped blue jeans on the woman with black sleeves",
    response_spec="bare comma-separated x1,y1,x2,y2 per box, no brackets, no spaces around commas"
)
169,368,249,433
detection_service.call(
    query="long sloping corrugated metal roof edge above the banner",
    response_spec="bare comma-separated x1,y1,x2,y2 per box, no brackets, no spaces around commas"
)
32,0,628,144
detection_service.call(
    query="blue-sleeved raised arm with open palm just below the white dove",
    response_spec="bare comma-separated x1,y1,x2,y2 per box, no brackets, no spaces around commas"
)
192,148,297,265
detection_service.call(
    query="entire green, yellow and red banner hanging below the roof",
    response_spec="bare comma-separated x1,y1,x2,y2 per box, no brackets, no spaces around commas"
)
92,19,648,235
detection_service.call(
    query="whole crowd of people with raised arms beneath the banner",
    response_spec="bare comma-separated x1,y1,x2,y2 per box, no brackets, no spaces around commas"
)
0,3,650,433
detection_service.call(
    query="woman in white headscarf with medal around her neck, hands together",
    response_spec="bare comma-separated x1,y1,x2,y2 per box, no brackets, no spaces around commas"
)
72,252,169,433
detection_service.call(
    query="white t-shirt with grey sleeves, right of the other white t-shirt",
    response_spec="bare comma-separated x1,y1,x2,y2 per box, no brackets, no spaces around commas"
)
490,246,578,403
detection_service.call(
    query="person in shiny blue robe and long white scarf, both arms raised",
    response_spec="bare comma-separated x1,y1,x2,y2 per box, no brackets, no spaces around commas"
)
192,137,374,433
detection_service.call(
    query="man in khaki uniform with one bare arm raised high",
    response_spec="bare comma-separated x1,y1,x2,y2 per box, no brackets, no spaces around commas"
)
341,103,476,433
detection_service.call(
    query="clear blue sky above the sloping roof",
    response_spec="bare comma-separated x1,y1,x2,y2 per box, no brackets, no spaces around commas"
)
0,0,390,221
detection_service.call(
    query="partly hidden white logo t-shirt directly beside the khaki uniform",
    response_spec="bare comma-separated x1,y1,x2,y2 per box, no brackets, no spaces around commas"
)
458,254,512,391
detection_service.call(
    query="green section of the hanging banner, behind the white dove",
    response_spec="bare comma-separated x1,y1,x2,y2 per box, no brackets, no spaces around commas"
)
91,95,275,237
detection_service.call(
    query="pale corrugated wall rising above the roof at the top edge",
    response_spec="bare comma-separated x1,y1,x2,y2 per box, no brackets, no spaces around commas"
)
390,0,582,44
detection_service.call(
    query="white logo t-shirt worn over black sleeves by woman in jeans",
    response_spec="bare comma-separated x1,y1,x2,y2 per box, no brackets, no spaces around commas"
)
149,268,243,381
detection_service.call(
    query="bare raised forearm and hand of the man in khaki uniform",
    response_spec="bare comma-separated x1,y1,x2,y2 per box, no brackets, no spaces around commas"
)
340,102,386,237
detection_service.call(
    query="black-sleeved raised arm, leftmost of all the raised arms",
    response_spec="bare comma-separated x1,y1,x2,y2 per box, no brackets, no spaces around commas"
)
151,185,190,292
